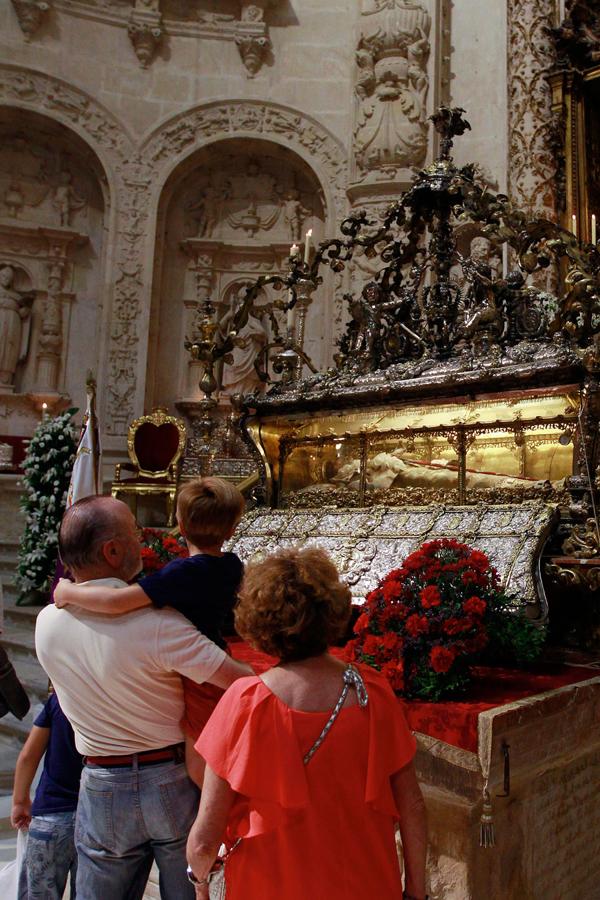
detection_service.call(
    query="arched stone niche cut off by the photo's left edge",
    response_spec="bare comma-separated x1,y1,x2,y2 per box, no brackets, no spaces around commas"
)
0,109,106,435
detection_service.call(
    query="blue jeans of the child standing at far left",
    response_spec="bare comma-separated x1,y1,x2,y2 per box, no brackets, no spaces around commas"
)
19,812,77,900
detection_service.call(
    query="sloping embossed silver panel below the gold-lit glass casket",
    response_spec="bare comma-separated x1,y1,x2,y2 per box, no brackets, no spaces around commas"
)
229,502,555,614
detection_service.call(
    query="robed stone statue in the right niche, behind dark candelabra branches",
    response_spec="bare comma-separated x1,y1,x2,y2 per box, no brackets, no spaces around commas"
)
219,282,268,394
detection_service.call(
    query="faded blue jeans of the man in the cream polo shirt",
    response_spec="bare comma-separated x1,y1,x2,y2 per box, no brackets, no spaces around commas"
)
75,762,200,900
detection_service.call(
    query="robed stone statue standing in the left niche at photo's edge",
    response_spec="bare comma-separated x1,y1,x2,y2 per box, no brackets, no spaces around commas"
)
0,266,34,389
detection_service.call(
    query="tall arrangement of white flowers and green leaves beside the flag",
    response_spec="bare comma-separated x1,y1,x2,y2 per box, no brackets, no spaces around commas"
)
17,409,77,599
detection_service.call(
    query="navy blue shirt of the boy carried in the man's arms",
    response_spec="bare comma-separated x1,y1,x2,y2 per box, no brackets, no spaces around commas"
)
138,553,244,649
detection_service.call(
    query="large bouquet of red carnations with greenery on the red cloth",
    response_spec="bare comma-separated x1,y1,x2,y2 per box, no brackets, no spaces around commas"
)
347,539,545,700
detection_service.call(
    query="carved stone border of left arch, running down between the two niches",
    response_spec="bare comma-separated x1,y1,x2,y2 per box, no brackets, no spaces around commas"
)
0,64,152,435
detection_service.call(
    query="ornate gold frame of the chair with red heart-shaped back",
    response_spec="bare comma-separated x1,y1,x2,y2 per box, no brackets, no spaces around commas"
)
111,407,186,527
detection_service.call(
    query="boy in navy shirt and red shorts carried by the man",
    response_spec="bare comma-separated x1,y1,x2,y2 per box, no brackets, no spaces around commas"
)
54,477,245,787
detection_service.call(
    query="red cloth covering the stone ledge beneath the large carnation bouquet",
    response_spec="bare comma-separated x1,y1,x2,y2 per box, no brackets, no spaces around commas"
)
230,639,596,753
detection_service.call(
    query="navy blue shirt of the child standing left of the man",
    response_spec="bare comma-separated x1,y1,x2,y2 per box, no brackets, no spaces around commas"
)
31,694,83,816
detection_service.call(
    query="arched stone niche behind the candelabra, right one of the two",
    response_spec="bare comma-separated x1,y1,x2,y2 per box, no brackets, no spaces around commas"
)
146,138,333,416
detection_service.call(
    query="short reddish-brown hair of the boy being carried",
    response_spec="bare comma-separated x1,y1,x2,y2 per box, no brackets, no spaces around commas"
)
177,476,246,547
